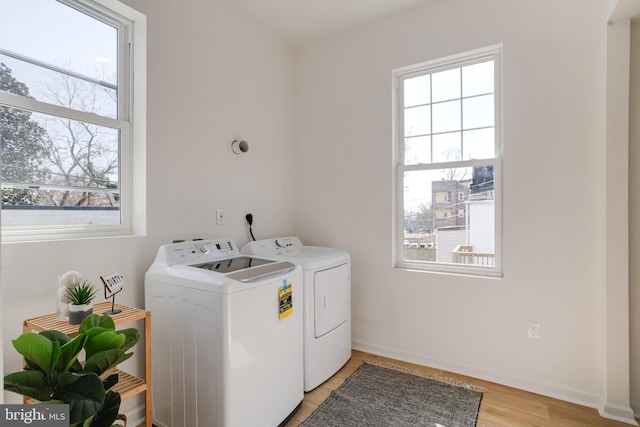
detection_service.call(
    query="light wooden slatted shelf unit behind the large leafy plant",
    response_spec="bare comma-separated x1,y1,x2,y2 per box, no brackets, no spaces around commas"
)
22,301,152,427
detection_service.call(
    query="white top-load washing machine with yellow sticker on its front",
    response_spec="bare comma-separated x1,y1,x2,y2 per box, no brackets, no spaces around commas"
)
145,240,304,427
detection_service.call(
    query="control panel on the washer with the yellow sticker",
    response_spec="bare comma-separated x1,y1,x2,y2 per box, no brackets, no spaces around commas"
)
161,239,240,265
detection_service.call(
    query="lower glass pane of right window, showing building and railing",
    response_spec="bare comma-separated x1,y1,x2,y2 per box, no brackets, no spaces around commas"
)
403,166,495,266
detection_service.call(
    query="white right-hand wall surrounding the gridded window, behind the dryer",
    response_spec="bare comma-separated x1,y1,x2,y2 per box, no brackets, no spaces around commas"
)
296,0,626,420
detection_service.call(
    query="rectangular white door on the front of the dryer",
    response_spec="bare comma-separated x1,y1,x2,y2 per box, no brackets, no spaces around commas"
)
313,264,351,338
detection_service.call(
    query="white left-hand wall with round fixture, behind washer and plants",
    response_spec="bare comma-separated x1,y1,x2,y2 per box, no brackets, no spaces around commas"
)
2,0,295,425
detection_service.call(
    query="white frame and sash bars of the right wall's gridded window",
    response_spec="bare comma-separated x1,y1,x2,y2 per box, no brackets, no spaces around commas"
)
392,44,503,278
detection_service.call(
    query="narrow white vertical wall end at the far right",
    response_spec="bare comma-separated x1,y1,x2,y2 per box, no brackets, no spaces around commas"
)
602,8,632,422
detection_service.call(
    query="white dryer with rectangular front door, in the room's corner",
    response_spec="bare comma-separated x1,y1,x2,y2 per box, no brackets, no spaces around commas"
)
241,237,351,391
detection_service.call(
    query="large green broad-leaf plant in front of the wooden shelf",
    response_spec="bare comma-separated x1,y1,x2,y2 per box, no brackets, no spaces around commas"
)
4,314,140,427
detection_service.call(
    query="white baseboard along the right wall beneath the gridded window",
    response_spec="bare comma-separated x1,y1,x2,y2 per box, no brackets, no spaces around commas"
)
352,340,638,425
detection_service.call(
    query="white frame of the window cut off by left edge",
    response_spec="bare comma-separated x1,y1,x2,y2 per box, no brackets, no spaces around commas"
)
0,0,147,243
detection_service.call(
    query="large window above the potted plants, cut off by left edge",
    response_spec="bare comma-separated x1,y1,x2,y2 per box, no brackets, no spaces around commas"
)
0,0,145,239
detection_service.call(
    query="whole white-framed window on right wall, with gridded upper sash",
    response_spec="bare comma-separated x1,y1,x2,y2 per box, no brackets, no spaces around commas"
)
393,46,502,276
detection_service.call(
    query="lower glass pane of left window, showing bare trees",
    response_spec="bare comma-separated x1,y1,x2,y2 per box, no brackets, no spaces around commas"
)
0,107,120,214
